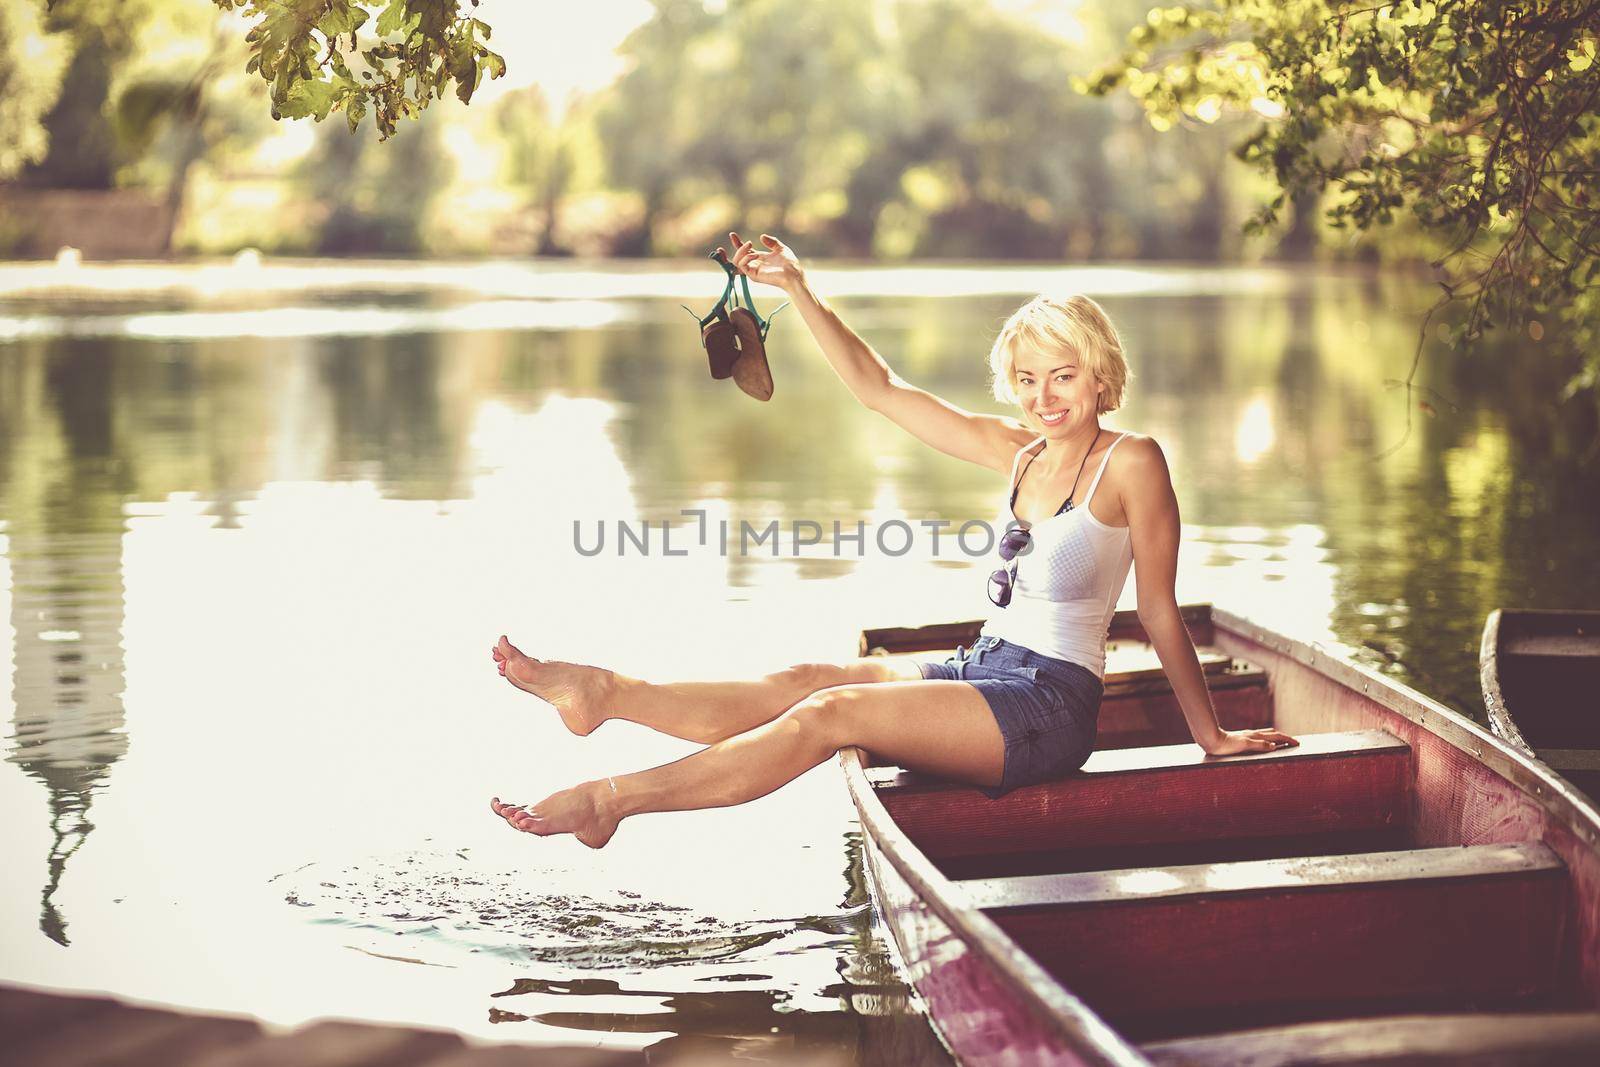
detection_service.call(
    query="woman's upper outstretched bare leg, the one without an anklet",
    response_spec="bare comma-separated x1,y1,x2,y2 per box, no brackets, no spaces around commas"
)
494,637,922,744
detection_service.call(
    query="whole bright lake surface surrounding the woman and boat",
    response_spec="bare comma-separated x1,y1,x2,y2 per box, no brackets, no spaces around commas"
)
0,255,1600,1064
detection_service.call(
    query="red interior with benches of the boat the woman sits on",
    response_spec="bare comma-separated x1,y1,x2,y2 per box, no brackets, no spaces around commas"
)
864,614,1600,1062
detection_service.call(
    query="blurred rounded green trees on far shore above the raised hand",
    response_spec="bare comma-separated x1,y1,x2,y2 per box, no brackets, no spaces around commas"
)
598,0,1248,258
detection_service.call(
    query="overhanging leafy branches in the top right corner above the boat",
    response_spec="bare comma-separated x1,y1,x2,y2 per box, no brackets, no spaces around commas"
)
1082,0,1600,363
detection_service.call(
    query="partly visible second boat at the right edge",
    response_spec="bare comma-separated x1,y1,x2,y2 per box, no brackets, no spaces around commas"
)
1478,608,1600,797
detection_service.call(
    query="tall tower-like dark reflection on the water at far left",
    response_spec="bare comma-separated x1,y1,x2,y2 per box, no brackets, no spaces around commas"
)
5,347,128,945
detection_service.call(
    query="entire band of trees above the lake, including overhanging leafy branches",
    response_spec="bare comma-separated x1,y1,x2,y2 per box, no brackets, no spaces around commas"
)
0,0,1600,379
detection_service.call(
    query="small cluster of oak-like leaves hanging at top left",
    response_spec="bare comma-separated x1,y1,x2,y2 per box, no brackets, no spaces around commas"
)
213,0,506,141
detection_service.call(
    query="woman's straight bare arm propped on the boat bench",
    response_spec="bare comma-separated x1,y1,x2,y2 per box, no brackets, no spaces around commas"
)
1118,437,1299,755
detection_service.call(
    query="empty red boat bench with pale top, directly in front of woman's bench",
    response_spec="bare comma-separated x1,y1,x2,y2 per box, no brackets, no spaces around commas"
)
957,841,1568,1038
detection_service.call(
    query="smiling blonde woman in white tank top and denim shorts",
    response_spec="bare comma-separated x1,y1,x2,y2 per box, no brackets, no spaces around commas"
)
491,234,1296,848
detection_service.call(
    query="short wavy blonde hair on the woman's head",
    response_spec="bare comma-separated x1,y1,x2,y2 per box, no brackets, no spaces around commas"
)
989,293,1133,414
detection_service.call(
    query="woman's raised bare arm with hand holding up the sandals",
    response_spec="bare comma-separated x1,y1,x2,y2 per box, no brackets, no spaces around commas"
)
728,234,1034,472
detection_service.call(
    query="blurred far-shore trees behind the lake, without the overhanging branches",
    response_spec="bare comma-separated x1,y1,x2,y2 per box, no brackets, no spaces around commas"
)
0,0,1312,261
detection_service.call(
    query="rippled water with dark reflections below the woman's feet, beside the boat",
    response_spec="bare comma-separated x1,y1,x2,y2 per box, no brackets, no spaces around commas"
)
264,830,950,1067
